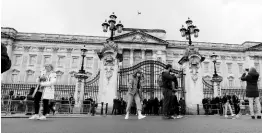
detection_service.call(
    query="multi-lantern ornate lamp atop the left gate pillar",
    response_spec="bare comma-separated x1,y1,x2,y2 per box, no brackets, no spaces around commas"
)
102,12,124,41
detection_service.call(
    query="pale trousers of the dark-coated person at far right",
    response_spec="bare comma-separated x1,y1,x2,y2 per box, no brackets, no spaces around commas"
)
248,97,261,116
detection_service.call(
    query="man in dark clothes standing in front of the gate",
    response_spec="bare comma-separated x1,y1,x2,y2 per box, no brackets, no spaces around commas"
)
162,64,178,119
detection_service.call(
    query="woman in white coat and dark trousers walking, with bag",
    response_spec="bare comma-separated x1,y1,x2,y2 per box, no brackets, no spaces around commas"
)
29,64,56,120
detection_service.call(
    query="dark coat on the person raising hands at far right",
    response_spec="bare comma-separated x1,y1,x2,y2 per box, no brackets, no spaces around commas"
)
241,73,259,97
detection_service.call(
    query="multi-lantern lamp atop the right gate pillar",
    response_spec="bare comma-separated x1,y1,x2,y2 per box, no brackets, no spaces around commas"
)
180,18,200,46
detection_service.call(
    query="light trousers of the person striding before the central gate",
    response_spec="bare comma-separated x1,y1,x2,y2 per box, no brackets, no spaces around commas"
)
126,93,142,113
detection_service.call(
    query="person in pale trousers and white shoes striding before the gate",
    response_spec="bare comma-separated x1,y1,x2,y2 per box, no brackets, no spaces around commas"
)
125,71,146,119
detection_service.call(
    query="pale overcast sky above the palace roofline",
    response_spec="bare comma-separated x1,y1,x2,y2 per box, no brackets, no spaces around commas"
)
1,0,262,44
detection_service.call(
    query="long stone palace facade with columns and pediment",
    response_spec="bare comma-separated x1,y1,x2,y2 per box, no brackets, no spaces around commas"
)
1,27,262,89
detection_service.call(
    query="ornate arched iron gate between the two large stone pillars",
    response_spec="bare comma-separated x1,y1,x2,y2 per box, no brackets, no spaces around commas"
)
117,60,185,100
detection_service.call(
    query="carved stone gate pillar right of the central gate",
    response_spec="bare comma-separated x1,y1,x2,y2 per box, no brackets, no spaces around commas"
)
178,46,205,114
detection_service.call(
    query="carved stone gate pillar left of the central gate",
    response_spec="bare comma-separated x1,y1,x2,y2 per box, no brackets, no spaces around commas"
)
98,41,122,111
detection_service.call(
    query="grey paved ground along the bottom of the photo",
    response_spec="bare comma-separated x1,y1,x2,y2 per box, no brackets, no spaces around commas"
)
1,116,262,133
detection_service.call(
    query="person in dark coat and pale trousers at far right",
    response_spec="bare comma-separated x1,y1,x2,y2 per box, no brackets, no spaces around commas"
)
241,67,261,119
